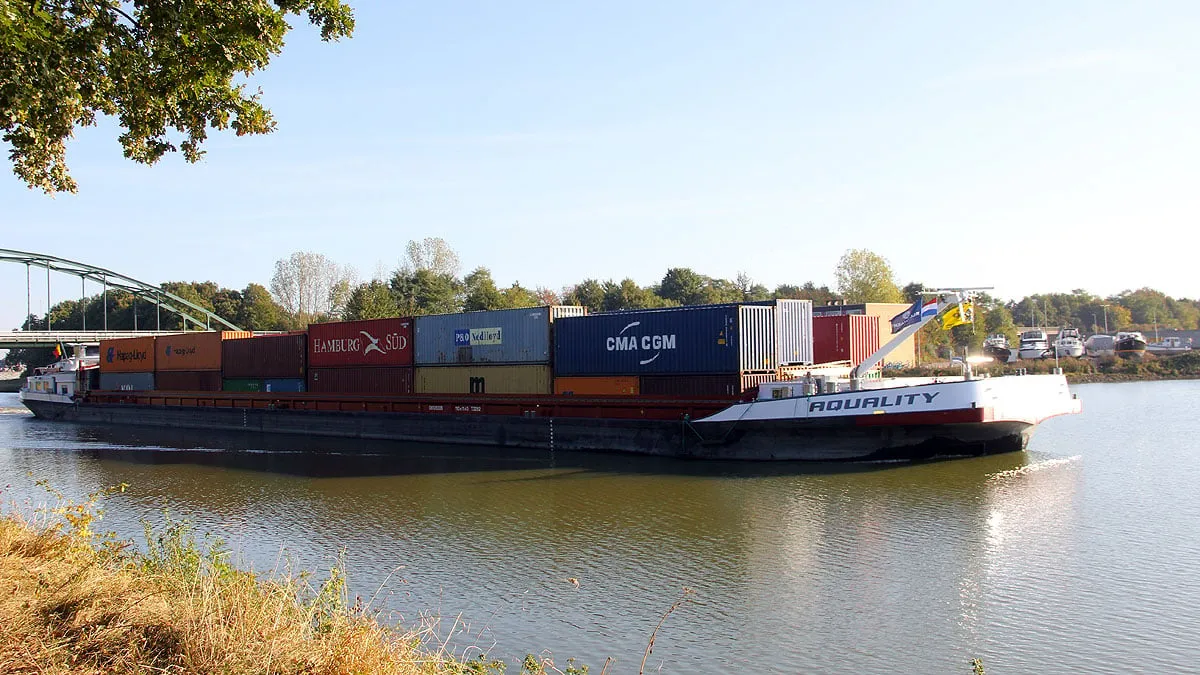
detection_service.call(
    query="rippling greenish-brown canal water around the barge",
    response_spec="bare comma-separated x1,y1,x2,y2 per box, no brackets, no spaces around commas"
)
0,381,1200,675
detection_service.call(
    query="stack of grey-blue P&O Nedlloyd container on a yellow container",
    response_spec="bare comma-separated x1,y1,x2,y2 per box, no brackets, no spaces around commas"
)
413,305,587,394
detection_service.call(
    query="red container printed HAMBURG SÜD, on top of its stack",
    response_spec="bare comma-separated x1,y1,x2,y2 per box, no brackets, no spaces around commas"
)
308,318,413,368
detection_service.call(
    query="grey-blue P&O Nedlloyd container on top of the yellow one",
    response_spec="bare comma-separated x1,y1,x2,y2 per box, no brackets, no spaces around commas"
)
413,305,587,365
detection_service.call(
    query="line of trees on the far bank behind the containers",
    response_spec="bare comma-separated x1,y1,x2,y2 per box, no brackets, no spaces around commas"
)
6,238,1200,363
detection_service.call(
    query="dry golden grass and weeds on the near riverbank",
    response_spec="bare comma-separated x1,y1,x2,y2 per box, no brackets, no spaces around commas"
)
0,485,588,675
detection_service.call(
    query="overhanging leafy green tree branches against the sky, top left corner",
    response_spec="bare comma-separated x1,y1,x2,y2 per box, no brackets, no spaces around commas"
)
0,0,354,193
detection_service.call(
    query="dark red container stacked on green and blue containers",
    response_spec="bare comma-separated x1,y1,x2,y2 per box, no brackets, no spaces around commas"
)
221,333,308,394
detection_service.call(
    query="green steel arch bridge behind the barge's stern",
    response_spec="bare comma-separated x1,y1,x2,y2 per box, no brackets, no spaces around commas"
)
0,249,240,341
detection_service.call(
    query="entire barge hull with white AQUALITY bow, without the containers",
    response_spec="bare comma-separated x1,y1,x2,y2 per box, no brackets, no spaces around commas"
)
24,376,1078,461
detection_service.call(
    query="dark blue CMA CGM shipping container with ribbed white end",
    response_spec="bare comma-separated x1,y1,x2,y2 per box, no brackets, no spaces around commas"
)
554,304,794,376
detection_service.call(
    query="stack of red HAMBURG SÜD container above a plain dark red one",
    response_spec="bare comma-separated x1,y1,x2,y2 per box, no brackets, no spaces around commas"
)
307,318,413,394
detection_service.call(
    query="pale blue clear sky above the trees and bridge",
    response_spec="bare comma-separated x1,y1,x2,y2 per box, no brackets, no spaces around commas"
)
0,0,1200,328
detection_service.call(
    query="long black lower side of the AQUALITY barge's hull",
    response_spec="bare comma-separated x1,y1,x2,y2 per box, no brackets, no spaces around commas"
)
25,401,1033,461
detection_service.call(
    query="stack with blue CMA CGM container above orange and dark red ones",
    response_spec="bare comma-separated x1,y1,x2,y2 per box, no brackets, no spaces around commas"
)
554,300,812,399
